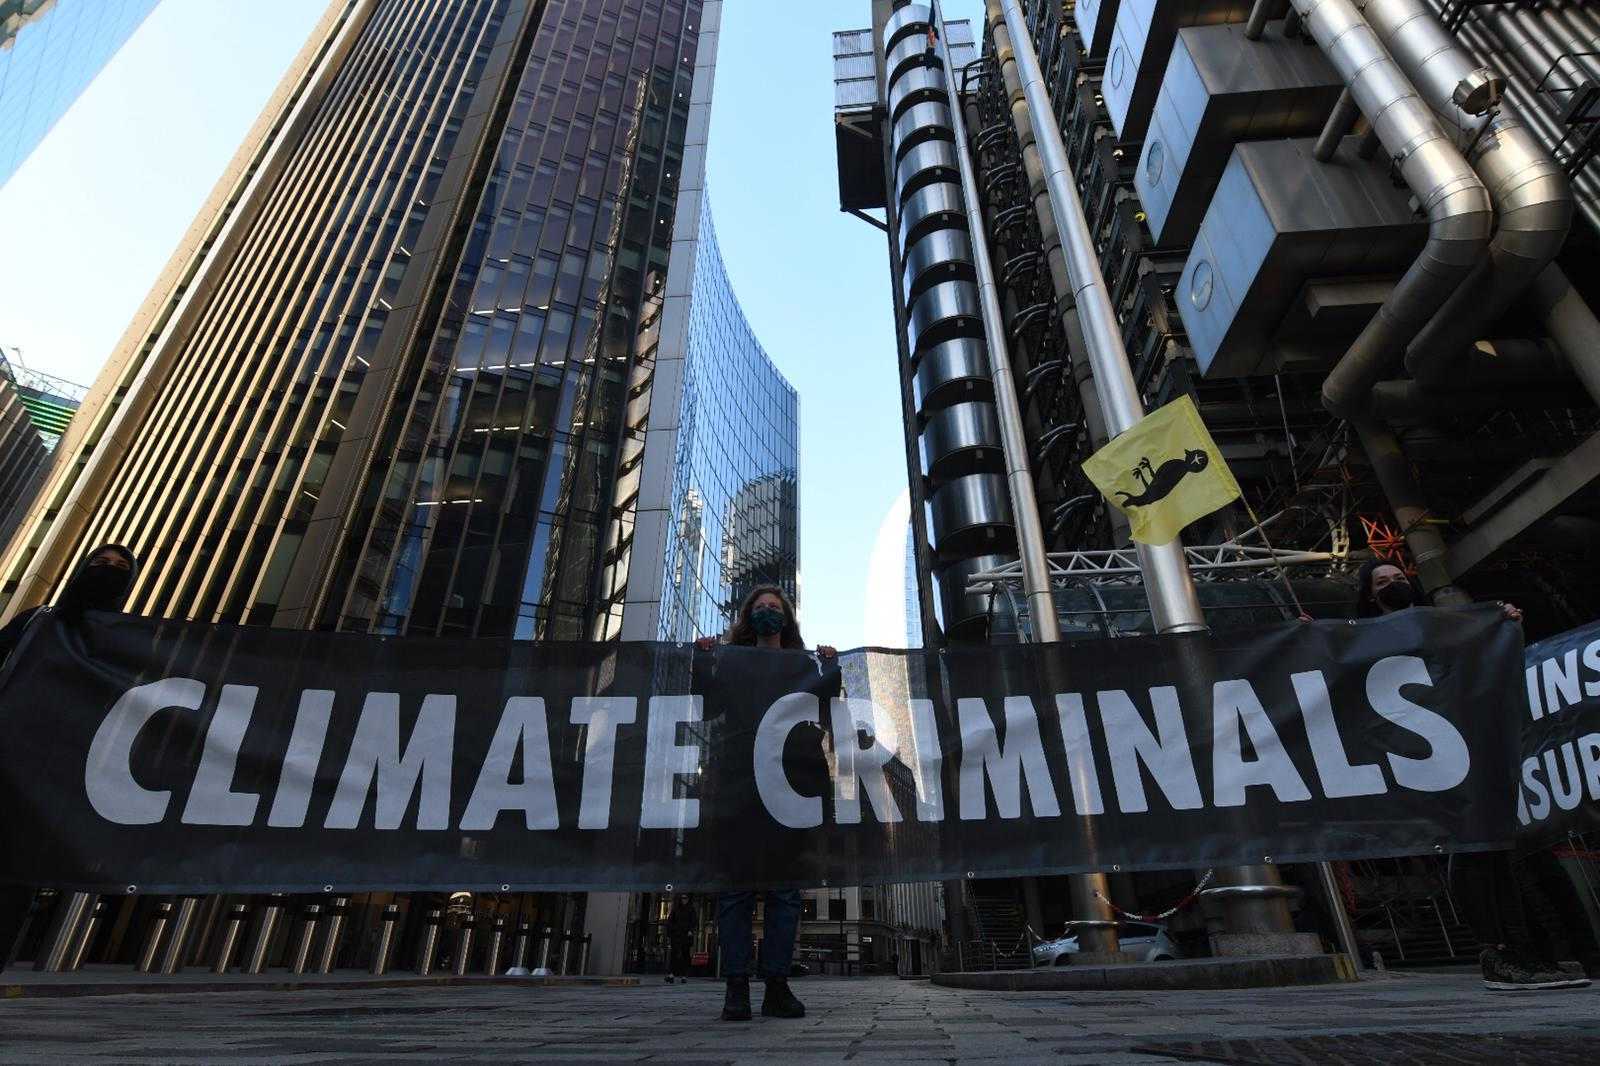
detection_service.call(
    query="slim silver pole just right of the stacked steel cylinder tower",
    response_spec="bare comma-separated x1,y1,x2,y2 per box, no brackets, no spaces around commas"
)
928,3,1126,962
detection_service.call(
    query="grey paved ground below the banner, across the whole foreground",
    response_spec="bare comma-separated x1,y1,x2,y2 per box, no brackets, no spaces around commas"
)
0,975,1600,1066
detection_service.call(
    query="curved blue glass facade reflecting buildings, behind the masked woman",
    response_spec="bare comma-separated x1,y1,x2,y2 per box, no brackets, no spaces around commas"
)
659,196,800,640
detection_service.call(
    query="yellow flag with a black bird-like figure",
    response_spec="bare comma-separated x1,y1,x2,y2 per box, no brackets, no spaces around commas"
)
1083,395,1240,544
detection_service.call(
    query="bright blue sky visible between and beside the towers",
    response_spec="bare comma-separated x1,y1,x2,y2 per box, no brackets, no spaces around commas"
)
0,0,979,647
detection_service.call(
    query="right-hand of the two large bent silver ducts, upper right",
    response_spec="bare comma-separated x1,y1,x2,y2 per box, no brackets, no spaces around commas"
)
1366,0,1573,386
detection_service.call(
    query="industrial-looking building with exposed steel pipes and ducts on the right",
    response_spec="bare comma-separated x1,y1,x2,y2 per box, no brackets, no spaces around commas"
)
834,0,1600,967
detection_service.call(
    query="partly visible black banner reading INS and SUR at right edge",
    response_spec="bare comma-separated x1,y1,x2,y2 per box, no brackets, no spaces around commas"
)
1517,623,1600,848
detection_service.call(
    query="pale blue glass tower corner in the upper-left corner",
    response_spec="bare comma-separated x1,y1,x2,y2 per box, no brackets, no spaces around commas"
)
0,0,157,186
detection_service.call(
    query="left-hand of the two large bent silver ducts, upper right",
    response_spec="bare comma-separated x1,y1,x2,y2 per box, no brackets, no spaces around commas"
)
1294,0,1494,418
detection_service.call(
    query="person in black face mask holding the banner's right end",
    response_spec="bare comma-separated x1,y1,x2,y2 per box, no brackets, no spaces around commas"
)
1355,559,1589,992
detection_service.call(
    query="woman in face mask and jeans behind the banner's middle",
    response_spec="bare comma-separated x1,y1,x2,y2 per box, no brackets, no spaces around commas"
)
696,584,838,1021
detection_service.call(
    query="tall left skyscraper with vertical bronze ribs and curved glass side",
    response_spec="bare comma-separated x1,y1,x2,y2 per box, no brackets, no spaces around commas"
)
0,0,798,973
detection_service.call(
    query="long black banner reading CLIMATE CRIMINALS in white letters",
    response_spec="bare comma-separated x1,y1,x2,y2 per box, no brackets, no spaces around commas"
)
0,608,1523,892
